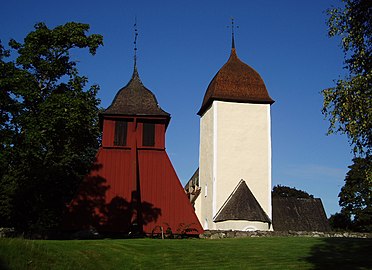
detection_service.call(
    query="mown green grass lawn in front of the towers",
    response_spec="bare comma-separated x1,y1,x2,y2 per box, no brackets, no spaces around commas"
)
0,237,372,270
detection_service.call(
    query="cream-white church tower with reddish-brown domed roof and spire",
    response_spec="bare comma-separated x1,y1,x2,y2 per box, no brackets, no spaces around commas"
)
194,30,274,230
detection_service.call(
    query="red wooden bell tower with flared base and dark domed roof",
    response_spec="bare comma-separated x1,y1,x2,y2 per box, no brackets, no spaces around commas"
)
64,65,203,234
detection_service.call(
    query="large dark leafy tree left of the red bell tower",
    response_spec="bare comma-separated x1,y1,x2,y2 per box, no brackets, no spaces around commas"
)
0,22,103,231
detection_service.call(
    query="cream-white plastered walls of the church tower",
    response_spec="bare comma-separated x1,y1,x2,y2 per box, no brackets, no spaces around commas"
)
195,101,272,230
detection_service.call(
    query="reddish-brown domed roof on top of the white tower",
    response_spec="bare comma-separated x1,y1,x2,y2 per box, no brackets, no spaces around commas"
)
198,46,274,116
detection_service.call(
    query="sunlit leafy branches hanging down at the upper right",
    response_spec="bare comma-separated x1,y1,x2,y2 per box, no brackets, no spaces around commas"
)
322,0,372,156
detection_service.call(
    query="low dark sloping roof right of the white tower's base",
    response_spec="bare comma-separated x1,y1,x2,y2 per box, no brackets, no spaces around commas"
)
272,197,330,231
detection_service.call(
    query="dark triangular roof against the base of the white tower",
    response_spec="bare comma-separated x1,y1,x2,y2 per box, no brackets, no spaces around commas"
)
214,180,271,223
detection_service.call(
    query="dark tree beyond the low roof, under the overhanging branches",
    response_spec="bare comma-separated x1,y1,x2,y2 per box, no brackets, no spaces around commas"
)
338,157,372,232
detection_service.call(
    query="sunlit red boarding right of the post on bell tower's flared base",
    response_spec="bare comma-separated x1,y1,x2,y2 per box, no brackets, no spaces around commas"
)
139,150,203,234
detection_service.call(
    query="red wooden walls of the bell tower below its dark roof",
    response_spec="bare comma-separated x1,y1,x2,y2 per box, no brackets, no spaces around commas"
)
65,117,203,234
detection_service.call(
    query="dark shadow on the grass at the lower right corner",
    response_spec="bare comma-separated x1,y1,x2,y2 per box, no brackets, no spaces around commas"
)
306,238,372,269
